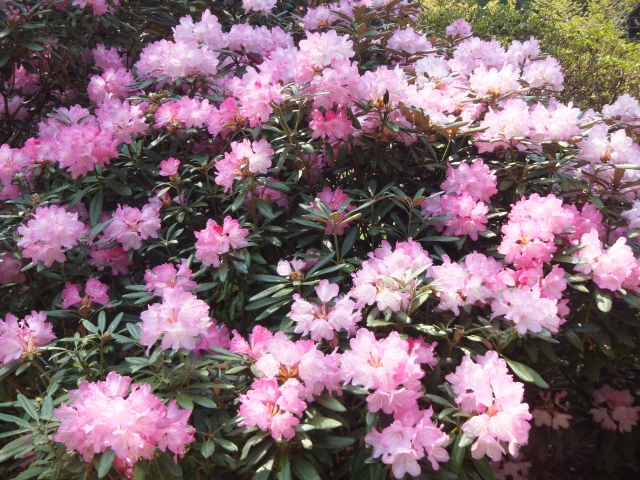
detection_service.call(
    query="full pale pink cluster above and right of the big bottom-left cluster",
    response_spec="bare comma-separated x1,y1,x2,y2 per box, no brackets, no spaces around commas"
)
140,288,211,354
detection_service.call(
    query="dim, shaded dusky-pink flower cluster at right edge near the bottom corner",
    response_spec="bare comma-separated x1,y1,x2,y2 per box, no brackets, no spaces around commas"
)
589,385,640,433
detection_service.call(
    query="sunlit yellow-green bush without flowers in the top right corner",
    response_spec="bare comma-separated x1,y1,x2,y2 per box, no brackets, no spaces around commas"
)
421,0,640,109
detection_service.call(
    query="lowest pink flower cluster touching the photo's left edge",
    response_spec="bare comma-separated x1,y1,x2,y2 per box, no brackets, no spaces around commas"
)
0,311,56,366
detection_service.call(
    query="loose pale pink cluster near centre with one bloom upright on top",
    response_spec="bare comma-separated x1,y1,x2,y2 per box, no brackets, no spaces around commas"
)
290,280,362,341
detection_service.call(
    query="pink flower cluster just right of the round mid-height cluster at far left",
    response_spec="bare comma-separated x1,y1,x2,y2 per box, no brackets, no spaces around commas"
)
104,203,161,252
